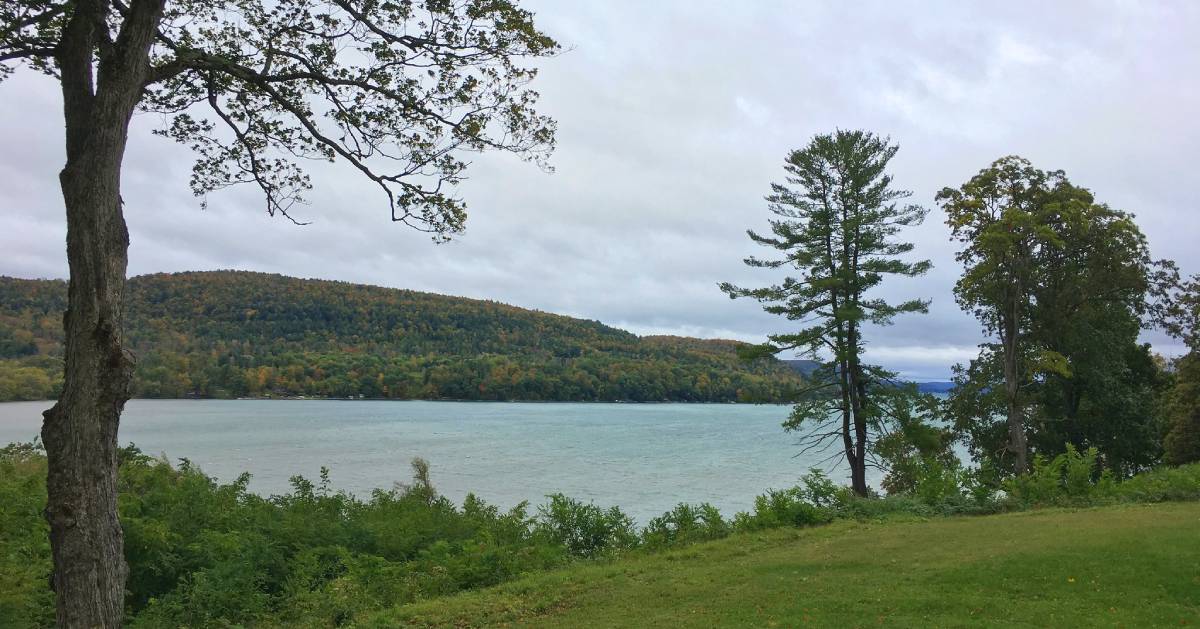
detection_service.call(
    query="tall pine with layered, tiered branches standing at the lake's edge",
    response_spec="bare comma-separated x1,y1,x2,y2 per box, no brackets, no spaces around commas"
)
721,130,930,496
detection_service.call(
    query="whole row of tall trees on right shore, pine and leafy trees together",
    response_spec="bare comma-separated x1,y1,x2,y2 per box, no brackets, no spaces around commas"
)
721,130,1200,496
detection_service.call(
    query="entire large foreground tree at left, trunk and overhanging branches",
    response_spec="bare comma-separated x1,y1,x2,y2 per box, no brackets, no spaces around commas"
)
0,0,557,627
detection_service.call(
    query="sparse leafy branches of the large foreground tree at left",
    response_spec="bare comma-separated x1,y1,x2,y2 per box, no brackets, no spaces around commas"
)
0,0,559,230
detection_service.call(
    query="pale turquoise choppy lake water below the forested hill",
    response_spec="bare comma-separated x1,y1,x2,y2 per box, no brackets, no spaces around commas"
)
0,400,868,523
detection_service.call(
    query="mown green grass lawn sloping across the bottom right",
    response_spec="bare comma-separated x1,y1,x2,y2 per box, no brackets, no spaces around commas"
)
360,503,1200,628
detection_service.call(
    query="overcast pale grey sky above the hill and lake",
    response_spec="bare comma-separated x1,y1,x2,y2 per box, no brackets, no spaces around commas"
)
0,0,1200,379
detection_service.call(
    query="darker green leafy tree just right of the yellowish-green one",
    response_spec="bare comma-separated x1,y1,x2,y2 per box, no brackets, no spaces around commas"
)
1031,186,1168,477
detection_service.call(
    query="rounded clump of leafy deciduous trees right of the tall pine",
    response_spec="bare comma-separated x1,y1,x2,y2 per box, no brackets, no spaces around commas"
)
937,157,1165,473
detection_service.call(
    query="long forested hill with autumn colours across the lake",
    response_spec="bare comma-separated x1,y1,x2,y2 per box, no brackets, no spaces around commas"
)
0,271,800,402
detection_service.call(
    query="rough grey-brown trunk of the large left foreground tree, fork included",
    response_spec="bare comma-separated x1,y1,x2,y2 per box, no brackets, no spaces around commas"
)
42,0,163,628
